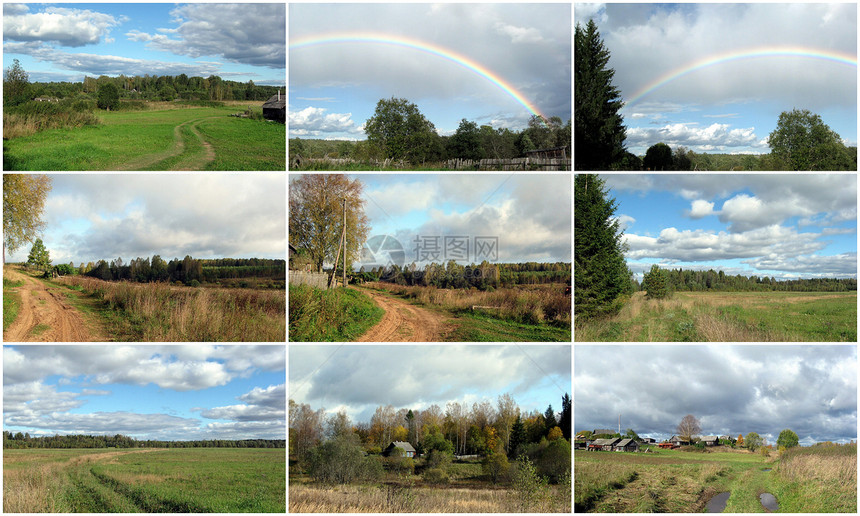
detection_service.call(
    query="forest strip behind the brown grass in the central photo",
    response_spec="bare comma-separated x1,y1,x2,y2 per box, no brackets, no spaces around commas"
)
357,260,571,290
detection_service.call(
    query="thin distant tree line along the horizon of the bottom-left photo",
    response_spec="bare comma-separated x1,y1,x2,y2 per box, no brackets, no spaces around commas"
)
3,431,286,450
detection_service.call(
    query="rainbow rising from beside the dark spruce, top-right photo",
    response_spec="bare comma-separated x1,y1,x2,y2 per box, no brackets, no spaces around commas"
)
627,47,857,105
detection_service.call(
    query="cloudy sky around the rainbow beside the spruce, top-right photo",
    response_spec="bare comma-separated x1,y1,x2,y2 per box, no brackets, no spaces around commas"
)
574,3,857,155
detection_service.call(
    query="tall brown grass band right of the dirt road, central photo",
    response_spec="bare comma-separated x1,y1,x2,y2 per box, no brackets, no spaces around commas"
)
367,282,571,327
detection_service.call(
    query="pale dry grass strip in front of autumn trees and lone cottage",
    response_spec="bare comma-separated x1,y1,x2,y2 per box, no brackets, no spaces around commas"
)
289,484,570,513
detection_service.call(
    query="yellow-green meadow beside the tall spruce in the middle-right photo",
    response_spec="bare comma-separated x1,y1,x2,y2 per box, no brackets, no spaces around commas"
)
574,292,857,342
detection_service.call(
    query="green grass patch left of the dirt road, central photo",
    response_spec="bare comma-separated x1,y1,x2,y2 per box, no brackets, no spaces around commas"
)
289,285,385,342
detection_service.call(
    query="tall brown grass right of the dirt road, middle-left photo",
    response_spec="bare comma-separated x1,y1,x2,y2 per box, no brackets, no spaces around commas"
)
62,276,286,342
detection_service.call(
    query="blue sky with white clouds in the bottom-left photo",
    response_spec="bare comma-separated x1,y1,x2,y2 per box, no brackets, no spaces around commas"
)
3,344,286,440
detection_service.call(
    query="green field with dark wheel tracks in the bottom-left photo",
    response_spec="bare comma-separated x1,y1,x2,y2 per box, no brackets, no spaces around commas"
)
3,448,286,513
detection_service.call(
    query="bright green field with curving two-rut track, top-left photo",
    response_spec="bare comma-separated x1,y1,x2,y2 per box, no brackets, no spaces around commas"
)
3,103,286,170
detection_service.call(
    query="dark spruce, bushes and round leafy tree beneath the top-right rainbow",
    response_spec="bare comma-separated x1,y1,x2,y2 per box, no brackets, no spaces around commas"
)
574,20,857,170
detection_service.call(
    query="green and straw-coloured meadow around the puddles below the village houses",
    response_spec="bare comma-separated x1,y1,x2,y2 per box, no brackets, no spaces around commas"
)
574,444,857,513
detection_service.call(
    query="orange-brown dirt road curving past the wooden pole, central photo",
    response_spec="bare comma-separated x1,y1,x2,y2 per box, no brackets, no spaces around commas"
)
356,288,452,342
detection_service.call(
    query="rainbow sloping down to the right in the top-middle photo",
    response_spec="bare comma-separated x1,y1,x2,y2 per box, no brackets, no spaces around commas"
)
290,32,547,118
